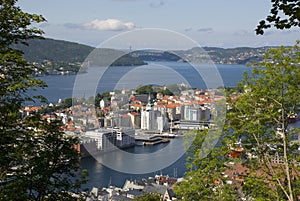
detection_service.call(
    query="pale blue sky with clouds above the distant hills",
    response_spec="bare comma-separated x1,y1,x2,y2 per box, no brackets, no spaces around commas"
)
18,0,300,48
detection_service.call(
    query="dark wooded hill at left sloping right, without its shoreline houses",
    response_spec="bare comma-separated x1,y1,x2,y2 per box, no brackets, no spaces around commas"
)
17,38,145,66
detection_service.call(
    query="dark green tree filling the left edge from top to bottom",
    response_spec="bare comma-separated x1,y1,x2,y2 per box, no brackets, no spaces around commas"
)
0,0,84,200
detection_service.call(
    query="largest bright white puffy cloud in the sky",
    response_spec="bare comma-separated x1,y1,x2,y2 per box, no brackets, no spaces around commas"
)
83,19,135,31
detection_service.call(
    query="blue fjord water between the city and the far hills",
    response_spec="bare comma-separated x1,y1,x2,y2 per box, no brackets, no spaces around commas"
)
32,62,250,103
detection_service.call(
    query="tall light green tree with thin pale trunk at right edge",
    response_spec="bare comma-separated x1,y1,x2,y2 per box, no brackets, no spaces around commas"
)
227,42,300,201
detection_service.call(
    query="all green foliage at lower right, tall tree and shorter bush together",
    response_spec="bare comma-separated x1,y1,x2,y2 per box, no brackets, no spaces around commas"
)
176,42,300,201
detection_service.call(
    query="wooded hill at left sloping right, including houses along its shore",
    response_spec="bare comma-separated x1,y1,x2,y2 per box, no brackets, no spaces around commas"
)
15,38,146,75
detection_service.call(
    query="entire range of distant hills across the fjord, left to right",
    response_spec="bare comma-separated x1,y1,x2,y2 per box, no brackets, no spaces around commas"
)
17,38,270,67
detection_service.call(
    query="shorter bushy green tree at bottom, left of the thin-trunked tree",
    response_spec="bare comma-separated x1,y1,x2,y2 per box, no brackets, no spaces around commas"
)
175,130,238,201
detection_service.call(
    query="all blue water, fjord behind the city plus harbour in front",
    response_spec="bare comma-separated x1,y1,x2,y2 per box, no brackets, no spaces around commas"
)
30,62,250,188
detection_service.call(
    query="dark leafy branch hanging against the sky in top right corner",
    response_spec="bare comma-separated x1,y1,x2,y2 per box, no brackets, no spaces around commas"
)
255,0,300,35
